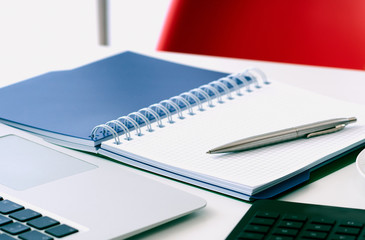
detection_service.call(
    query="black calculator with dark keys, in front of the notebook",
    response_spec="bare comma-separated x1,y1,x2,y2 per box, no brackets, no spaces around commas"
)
227,200,365,240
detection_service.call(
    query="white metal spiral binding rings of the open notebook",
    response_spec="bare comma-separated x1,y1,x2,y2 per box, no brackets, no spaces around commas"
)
91,68,270,144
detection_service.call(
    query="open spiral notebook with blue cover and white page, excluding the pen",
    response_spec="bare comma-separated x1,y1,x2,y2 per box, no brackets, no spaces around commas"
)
0,52,365,200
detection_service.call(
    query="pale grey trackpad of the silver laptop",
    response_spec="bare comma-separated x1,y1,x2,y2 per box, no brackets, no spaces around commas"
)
0,135,97,190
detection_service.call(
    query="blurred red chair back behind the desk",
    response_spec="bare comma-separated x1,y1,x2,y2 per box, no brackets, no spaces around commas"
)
157,0,365,70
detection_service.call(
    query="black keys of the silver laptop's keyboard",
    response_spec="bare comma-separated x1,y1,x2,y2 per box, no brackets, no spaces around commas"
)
0,196,78,240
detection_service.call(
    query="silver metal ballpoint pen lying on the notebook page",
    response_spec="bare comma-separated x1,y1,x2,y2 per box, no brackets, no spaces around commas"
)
207,117,356,154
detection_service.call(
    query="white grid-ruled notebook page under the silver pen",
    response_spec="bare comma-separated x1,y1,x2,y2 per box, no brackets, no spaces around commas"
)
102,82,365,192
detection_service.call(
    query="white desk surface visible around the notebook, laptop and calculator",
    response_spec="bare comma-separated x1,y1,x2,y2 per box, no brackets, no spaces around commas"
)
0,46,365,239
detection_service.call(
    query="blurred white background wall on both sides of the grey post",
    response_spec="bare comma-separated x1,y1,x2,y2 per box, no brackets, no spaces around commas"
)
0,0,170,50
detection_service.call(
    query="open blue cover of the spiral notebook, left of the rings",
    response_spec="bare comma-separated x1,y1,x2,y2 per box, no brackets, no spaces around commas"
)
0,52,227,146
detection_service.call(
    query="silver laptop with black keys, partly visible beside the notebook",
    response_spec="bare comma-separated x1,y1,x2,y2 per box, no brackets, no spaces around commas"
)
0,124,206,240
